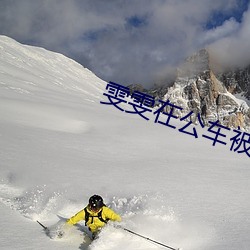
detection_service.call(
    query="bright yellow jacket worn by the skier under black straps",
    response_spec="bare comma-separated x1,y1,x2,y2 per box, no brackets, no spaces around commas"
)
67,206,122,233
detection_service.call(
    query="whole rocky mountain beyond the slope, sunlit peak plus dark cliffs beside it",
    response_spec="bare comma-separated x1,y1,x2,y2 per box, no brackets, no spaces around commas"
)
135,49,250,130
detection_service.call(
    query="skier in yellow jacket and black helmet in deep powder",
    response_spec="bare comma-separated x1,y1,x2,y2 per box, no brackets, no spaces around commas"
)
67,194,122,239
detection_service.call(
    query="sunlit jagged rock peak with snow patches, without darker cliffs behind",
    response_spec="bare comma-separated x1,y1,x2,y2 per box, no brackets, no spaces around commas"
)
160,49,250,129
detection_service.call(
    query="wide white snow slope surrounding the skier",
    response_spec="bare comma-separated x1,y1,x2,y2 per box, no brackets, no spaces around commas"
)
0,36,250,250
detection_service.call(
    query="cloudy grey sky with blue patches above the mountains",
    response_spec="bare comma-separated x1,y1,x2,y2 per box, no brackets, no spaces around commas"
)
0,0,250,86
